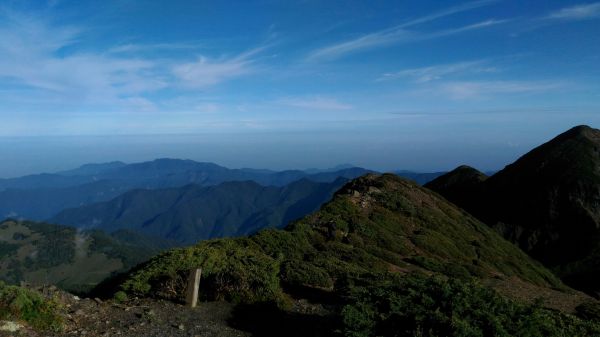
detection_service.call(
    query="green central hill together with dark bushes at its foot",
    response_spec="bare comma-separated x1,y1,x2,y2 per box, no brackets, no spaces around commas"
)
105,175,600,336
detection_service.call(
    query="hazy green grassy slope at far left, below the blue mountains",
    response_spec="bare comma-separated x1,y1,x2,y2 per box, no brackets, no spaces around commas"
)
0,220,172,291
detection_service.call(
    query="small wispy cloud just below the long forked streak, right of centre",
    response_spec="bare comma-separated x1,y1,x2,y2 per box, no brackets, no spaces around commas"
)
377,60,497,83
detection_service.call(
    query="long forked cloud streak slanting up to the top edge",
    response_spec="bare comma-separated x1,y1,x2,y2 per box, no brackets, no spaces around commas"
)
307,1,503,61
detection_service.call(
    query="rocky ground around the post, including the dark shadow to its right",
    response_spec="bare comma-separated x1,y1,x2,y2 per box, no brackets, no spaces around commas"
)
0,286,332,337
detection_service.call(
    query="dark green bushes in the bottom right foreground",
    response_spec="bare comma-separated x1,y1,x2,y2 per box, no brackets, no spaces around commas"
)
341,275,600,337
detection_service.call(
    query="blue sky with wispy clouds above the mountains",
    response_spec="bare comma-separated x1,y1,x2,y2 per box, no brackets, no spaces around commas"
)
0,0,600,177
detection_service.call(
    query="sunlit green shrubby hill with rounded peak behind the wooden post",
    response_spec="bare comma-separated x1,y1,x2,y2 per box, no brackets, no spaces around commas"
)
118,175,584,298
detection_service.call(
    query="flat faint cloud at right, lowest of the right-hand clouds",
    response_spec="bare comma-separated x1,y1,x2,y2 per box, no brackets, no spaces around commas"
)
434,81,564,100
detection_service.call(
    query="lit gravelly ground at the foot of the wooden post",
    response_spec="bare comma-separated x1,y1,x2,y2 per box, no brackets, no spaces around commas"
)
0,286,251,337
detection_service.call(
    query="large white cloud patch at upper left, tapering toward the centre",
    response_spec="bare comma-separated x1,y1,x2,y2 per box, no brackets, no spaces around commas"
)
0,8,265,112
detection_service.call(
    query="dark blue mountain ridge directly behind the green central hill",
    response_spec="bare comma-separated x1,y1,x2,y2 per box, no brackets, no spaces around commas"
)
50,178,346,244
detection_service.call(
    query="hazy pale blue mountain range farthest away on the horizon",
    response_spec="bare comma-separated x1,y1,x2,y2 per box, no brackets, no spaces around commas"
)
0,159,438,221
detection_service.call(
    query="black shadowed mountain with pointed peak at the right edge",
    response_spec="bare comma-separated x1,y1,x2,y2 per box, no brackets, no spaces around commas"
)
425,126,600,296
